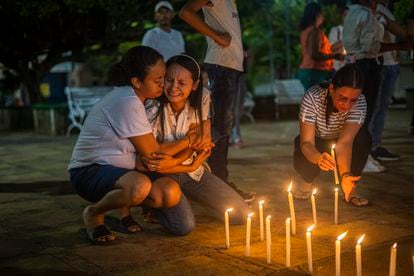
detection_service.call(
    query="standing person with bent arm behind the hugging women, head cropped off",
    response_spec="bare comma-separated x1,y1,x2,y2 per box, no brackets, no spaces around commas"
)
179,0,255,201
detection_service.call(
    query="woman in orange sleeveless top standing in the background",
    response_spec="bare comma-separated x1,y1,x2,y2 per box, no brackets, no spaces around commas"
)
297,2,342,90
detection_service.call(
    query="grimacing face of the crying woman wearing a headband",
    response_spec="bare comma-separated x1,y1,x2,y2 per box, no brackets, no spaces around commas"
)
164,63,198,105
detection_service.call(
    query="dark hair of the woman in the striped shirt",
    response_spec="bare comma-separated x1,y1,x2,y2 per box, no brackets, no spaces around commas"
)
321,63,364,124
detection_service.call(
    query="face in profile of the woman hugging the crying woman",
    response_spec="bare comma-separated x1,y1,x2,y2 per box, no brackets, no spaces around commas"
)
138,59,165,99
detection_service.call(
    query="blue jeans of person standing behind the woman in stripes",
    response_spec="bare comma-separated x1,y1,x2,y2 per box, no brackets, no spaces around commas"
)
369,64,400,148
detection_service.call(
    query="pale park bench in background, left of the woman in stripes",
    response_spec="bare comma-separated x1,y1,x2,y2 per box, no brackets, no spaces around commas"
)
273,79,305,119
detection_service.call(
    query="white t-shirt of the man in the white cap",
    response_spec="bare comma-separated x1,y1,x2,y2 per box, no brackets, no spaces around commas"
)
142,27,185,61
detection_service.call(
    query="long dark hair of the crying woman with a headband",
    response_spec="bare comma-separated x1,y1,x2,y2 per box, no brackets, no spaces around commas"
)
158,54,203,141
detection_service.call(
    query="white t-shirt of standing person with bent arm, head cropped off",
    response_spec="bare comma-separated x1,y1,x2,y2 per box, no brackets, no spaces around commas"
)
202,0,243,72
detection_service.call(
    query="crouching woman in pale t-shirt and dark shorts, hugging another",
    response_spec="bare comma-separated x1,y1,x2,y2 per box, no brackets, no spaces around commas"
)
68,46,194,244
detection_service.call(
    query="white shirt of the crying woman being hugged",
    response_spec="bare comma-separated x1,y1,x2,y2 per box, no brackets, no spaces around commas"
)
145,88,211,181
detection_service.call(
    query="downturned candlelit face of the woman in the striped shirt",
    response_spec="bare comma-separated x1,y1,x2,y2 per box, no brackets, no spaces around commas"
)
330,86,361,112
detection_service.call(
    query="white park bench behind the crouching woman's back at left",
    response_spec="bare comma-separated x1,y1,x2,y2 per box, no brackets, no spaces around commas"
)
65,86,112,135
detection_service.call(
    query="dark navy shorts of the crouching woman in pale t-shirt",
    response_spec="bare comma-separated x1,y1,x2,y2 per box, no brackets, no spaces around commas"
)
69,164,165,202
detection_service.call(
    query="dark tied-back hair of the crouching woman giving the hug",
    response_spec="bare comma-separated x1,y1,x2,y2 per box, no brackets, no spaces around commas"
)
108,46,163,86
